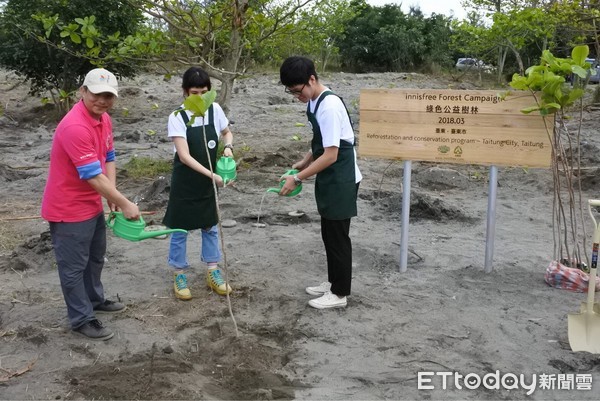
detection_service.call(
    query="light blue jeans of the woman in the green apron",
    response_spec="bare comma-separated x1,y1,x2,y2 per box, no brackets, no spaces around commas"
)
168,226,221,269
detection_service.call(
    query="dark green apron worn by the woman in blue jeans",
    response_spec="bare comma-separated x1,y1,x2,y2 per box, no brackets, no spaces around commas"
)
163,105,219,230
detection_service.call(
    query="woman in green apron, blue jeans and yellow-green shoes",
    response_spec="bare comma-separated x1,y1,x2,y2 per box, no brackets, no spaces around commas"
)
163,67,233,300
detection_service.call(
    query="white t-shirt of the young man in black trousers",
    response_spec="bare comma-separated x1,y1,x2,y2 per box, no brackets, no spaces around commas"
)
308,88,362,182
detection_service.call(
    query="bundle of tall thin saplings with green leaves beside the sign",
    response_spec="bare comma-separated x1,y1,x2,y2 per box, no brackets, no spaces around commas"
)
510,46,590,266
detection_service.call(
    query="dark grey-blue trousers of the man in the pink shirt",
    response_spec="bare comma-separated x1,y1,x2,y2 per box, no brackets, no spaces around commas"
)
50,213,106,329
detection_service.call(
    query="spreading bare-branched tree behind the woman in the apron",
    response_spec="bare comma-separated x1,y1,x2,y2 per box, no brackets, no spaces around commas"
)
129,0,324,109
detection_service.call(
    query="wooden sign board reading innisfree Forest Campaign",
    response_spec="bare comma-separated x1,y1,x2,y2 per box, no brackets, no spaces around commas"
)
358,89,553,167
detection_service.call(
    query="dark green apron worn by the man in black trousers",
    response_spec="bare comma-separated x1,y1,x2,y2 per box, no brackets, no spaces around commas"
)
306,91,357,220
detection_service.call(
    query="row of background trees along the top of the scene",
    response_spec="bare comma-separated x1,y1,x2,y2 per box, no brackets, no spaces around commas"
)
0,0,600,115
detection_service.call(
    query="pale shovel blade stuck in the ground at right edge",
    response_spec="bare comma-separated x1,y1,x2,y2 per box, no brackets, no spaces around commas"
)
568,304,600,354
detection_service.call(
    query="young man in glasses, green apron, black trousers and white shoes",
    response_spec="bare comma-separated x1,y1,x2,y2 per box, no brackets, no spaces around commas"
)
279,56,362,309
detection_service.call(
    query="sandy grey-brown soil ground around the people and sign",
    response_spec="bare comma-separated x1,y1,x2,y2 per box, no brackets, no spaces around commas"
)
0,67,600,400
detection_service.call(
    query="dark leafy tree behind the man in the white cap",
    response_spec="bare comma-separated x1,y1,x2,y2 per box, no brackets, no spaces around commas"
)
0,0,143,113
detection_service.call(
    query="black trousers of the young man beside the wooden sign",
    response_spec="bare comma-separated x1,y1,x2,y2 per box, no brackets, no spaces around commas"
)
321,217,352,296
